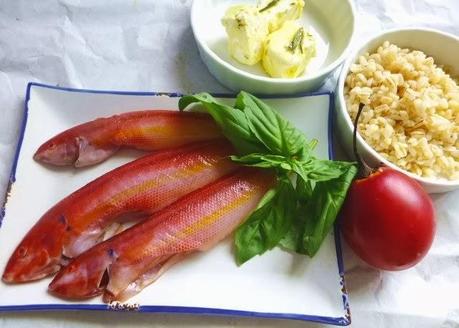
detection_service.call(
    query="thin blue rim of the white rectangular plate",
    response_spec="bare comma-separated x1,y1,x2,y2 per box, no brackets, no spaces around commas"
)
0,82,351,326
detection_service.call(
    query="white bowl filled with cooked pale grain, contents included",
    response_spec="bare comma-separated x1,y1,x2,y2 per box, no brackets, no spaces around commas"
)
335,28,459,193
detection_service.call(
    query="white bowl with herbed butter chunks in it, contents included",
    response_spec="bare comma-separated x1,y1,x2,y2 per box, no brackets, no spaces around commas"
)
191,0,355,95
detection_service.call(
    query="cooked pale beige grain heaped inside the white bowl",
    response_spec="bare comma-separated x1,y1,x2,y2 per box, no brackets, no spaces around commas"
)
344,41,459,180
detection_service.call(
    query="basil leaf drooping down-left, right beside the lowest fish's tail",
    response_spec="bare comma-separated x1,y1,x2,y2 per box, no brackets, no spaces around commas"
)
234,177,296,265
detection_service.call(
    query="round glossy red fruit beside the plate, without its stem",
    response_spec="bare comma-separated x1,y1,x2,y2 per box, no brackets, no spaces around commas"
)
341,167,436,271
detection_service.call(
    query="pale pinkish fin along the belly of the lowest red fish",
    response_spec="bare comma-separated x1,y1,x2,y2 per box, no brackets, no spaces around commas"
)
103,253,187,303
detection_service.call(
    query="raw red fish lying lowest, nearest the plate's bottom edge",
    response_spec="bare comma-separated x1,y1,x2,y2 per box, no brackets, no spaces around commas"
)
49,168,274,302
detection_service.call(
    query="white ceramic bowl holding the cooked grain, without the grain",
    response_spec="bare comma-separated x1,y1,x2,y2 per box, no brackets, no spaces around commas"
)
335,28,459,193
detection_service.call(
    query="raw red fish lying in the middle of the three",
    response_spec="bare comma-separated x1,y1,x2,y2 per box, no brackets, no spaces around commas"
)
3,141,238,283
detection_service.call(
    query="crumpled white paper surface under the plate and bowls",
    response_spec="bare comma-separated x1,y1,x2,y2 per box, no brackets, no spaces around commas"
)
0,0,459,328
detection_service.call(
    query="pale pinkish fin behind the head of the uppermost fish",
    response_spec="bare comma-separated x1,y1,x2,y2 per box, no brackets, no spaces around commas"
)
74,137,119,167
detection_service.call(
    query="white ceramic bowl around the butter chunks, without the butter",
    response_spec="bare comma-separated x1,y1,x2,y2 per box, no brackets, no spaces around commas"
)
191,0,355,95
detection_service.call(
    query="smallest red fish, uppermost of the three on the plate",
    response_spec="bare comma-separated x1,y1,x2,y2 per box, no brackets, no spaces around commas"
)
34,110,222,167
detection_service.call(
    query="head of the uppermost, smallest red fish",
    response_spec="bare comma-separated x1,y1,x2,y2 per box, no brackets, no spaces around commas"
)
33,135,78,166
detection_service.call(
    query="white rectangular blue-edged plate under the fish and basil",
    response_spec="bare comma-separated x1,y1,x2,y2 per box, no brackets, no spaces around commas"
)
0,83,350,325
